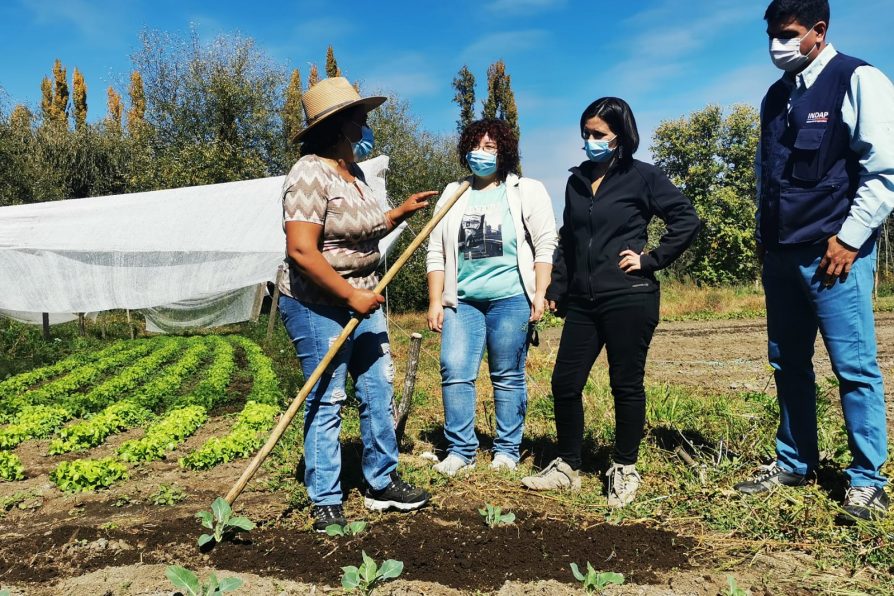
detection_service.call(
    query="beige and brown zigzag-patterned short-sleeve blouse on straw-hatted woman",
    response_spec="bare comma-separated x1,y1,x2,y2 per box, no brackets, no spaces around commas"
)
279,155,388,305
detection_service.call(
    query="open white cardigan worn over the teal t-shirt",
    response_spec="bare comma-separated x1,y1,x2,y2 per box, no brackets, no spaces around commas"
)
426,174,557,308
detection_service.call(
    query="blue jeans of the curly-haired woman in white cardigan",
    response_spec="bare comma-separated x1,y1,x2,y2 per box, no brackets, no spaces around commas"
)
441,294,531,462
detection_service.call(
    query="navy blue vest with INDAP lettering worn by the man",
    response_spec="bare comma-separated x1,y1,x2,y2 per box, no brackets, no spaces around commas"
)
758,54,866,248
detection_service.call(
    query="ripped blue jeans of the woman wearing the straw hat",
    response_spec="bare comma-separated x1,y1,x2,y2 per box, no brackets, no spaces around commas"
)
279,296,397,505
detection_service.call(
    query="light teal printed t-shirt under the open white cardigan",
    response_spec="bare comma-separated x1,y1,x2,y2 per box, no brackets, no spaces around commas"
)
456,184,525,301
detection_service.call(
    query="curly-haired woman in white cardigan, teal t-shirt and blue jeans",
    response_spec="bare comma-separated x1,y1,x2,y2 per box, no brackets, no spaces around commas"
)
427,119,556,476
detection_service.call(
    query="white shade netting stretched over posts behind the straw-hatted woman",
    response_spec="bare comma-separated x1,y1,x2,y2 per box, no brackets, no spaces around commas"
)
0,156,403,331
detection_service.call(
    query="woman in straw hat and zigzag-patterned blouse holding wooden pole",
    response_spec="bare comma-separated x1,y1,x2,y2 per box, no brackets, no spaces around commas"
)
279,77,436,532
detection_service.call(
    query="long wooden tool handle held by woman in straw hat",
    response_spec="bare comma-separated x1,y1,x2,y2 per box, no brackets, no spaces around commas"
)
226,180,469,505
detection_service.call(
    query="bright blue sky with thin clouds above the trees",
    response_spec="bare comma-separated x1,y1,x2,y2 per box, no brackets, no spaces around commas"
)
0,0,894,203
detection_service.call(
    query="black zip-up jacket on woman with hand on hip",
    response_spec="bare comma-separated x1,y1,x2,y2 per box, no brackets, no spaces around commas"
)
546,160,701,303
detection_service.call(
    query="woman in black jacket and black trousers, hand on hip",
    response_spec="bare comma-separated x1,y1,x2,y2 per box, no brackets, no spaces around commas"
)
522,97,701,507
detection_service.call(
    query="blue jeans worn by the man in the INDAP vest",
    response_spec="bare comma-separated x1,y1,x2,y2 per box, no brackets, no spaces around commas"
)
763,240,888,487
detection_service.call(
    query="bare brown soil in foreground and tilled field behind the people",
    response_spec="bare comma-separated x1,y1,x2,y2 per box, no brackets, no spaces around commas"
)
0,313,894,596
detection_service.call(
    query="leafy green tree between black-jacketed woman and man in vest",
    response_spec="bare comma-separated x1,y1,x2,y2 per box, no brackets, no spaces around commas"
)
651,105,760,284
